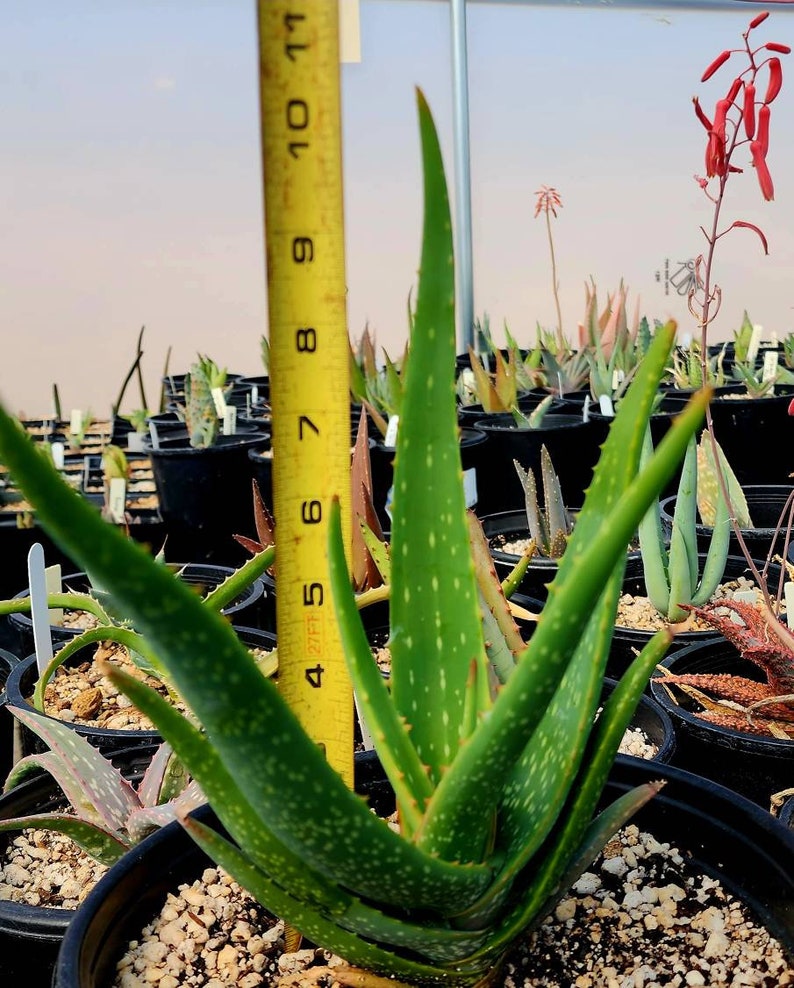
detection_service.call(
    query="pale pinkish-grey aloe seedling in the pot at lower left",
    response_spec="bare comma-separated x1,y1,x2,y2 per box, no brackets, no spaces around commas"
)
0,707,205,865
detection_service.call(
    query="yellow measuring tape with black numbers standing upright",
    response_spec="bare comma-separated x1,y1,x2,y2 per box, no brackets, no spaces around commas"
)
258,0,353,784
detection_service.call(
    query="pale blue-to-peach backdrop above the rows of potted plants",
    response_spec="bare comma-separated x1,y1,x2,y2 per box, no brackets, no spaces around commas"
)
0,0,794,416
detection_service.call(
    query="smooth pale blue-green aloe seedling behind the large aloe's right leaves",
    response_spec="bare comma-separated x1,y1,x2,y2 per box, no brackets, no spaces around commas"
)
639,430,731,623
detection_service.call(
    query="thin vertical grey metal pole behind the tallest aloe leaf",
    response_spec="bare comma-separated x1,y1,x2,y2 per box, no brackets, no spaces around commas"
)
449,0,474,352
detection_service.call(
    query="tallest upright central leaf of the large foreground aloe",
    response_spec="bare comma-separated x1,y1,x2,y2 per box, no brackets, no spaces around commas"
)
390,93,487,796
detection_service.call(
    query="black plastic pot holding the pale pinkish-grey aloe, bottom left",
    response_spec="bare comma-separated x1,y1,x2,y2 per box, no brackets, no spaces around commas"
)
0,746,155,988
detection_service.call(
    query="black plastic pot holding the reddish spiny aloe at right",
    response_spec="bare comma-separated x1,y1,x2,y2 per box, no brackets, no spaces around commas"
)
651,638,794,810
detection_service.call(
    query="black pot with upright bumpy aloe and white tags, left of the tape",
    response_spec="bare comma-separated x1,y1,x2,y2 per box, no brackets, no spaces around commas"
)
142,432,269,565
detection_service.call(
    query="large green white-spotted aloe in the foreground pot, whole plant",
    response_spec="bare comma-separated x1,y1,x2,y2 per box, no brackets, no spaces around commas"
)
0,94,706,985
